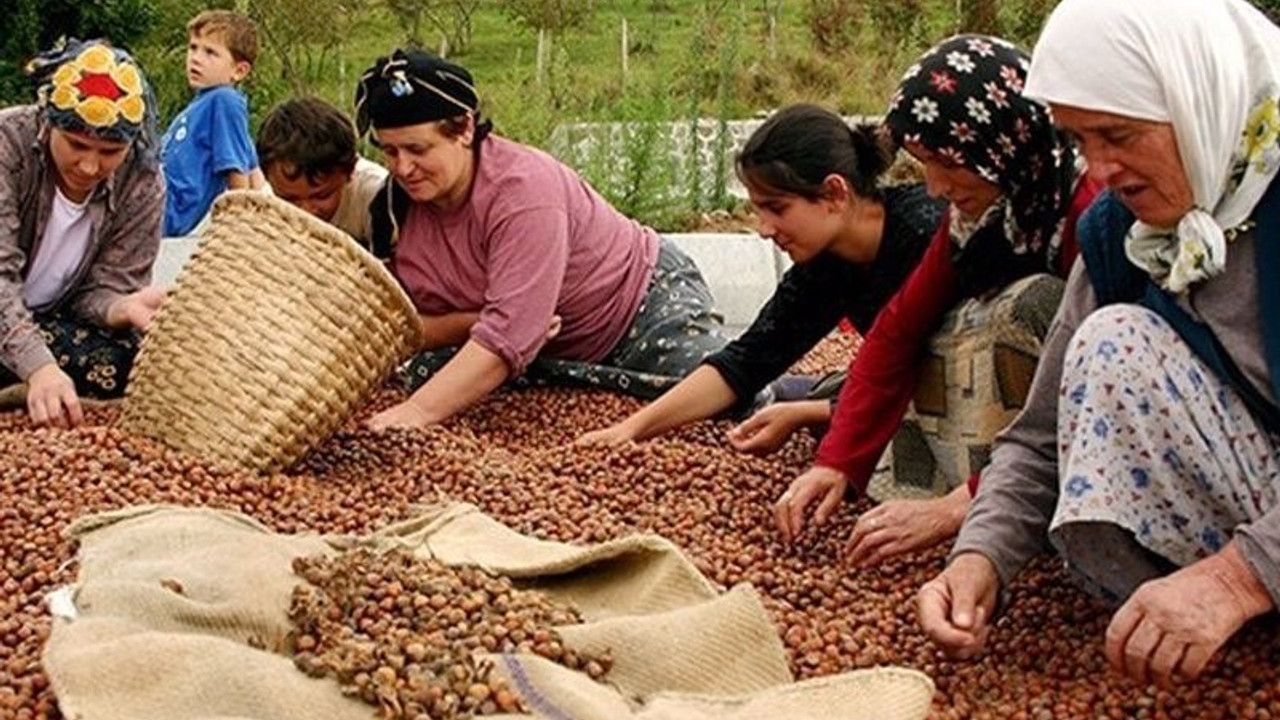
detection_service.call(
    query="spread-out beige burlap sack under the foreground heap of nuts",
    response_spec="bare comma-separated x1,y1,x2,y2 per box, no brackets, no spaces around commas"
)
44,505,933,720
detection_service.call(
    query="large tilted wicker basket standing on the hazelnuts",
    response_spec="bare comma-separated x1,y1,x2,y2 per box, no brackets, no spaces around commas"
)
120,191,421,471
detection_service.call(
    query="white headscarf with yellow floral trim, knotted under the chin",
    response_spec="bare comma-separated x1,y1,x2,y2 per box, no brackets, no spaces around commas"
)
1025,0,1280,293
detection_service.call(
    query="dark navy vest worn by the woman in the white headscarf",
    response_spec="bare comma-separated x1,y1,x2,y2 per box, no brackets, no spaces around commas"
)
1075,182,1280,433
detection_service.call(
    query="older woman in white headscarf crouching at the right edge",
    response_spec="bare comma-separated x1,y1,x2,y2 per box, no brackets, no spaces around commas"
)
919,0,1280,683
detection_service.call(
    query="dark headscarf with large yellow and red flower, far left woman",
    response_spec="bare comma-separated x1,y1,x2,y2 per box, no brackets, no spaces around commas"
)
26,40,155,146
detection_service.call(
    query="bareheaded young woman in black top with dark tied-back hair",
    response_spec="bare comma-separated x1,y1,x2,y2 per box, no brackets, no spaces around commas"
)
580,105,942,445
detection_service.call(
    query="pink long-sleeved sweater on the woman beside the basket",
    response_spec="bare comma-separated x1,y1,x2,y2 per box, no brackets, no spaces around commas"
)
393,136,658,375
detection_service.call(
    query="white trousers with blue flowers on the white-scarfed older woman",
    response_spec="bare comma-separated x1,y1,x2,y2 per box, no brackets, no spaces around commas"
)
1050,299,1280,596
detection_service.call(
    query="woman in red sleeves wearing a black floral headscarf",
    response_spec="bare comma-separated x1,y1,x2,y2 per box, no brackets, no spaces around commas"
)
774,35,1098,564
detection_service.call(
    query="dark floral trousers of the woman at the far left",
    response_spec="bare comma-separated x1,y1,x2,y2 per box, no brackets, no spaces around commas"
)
0,313,140,398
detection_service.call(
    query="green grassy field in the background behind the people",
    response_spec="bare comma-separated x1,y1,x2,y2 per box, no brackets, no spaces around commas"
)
162,0,1049,145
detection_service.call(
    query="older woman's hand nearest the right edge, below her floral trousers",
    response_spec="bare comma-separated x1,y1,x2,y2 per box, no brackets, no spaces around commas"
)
1106,542,1274,688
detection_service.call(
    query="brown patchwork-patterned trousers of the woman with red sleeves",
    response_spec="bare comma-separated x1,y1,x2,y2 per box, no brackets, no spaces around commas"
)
868,274,1064,501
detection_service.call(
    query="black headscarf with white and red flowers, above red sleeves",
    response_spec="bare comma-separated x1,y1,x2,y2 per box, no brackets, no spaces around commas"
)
884,35,1079,296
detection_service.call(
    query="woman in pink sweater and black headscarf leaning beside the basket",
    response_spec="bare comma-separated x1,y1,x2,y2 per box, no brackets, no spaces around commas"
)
356,50,726,428
